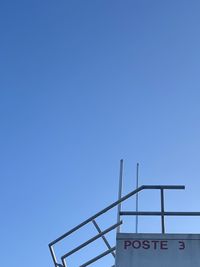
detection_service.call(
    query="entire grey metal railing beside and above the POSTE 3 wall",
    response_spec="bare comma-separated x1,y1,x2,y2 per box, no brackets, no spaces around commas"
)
49,185,200,267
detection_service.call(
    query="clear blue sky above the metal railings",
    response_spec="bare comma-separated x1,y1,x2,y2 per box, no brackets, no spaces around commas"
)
0,0,200,267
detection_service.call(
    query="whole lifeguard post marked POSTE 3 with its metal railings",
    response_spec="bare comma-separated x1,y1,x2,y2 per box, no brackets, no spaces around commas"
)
49,160,200,267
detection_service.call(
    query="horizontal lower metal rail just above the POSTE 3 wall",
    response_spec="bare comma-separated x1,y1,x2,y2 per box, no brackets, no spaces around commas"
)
120,211,200,216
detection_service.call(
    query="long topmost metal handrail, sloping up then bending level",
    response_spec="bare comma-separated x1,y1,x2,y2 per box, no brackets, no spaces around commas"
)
49,185,185,246
